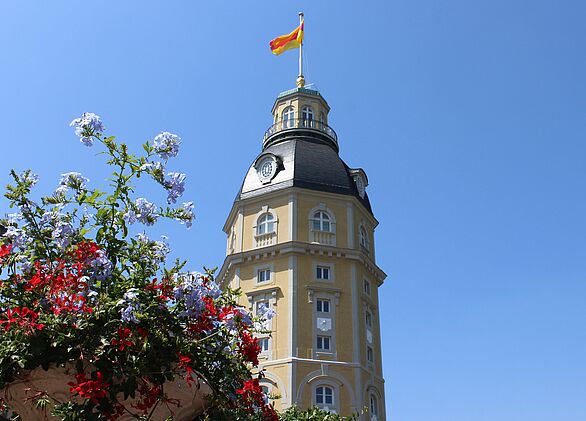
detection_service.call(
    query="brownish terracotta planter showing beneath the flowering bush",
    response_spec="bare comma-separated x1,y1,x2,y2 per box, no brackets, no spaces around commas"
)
0,365,212,421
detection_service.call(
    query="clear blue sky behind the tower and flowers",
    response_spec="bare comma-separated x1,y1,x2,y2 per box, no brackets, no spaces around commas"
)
0,0,586,421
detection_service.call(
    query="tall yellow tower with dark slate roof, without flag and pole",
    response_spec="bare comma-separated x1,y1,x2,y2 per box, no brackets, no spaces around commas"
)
218,83,386,420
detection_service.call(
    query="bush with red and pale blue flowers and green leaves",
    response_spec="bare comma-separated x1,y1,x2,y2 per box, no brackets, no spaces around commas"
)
0,113,278,420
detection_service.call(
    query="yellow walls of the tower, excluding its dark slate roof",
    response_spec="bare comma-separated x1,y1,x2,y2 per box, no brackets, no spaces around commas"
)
218,87,386,420
